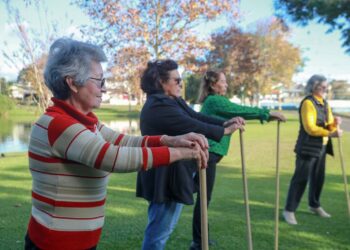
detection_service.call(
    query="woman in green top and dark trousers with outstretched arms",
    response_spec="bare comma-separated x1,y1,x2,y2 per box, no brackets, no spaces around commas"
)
191,70,285,249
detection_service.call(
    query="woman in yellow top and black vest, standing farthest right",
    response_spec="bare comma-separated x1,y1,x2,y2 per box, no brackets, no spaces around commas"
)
283,75,342,225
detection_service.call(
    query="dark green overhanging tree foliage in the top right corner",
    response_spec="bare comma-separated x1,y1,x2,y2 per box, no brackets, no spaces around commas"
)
275,0,350,53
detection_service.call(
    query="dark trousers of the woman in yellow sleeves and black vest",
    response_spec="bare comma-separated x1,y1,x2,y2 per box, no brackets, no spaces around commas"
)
285,146,326,212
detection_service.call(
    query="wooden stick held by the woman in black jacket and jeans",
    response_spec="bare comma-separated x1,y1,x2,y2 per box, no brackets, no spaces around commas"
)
239,130,253,250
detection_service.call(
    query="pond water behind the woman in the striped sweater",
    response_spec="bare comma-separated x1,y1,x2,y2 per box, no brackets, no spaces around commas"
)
0,119,140,153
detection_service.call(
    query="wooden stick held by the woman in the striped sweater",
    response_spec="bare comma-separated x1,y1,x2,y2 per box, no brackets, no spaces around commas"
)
198,166,209,250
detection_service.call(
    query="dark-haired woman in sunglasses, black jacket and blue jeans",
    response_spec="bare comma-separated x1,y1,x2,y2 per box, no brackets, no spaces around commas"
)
137,60,244,250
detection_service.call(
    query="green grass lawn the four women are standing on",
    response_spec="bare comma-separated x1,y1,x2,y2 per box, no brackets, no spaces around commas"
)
0,112,350,250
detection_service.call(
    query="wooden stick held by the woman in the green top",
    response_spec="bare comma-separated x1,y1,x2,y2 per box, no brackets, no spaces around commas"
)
275,121,281,250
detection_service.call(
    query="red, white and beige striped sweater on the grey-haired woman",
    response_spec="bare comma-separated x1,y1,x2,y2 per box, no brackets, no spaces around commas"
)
28,98,170,249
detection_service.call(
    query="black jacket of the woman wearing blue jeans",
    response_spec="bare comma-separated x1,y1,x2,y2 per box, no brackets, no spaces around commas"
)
136,94,224,204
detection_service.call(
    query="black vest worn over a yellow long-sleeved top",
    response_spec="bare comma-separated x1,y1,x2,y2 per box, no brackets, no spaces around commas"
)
294,95,333,157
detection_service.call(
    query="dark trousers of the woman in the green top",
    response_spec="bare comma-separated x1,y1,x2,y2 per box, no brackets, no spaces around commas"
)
192,153,222,244
